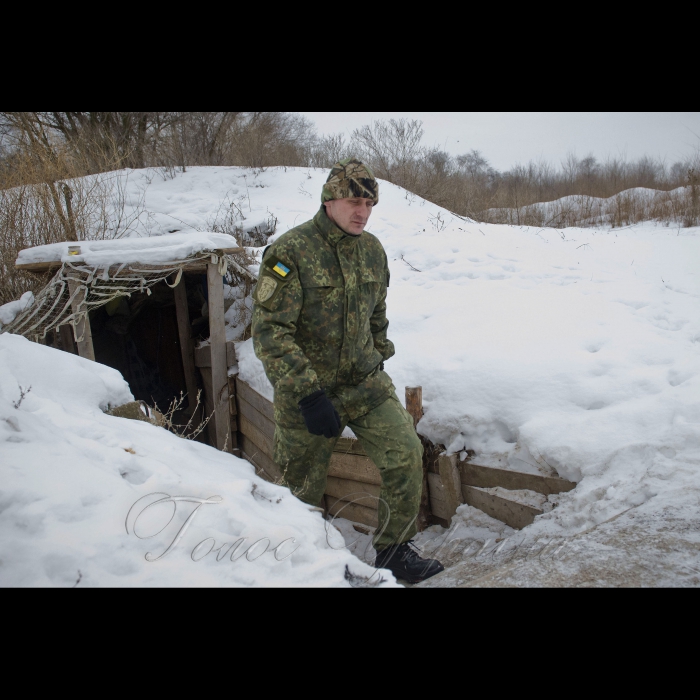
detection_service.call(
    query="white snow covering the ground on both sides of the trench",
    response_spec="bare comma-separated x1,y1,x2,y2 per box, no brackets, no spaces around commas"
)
0,168,700,585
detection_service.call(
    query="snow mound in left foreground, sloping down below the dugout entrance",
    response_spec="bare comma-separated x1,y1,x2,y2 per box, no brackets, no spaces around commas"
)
0,334,396,587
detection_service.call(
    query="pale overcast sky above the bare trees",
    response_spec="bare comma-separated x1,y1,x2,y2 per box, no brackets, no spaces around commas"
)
301,112,700,170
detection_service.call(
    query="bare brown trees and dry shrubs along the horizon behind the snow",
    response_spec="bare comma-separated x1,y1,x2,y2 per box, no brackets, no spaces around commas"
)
0,112,700,303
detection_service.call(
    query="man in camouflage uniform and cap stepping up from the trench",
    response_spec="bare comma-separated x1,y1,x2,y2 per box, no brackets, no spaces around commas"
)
253,158,442,582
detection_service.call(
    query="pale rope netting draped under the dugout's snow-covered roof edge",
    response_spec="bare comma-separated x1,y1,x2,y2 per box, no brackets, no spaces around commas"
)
0,252,255,342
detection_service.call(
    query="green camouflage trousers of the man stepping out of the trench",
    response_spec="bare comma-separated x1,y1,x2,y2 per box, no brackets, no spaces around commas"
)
274,393,423,550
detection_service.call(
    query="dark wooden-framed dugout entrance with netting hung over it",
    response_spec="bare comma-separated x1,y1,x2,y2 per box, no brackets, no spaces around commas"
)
13,248,243,452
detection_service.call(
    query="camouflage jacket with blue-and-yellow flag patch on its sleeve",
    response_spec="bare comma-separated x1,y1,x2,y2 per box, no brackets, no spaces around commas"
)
253,207,394,428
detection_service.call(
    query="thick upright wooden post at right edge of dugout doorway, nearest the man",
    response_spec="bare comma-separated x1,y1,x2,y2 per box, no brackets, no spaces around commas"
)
207,263,233,452
